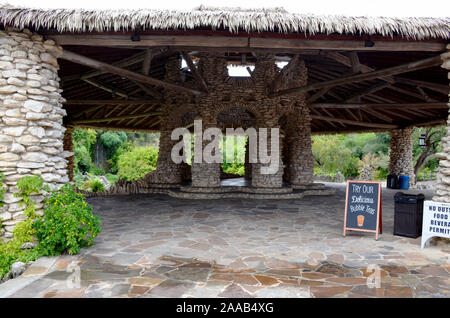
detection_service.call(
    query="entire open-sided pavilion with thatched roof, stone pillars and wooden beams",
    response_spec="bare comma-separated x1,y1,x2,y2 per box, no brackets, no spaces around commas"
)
0,5,450,235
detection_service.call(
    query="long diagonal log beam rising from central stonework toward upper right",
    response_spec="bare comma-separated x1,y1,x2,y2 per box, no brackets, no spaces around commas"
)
271,55,442,97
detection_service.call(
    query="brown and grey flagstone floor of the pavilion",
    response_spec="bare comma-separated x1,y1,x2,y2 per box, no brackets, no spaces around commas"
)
0,184,450,298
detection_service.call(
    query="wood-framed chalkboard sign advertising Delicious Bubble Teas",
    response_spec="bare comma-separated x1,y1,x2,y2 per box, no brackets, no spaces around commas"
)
344,181,381,240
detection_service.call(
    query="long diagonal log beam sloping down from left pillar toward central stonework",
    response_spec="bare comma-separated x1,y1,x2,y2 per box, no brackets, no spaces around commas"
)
60,50,202,95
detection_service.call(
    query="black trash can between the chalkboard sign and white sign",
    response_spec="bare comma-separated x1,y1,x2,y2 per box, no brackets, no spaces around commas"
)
394,192,425,238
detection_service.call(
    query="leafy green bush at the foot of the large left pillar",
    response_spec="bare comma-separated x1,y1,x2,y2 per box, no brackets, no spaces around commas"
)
33,184,101,256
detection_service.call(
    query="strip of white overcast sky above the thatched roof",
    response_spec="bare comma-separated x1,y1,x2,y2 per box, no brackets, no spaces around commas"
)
7,0,450,17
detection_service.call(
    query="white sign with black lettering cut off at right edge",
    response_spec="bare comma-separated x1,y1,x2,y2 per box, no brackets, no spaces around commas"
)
422,201,450,248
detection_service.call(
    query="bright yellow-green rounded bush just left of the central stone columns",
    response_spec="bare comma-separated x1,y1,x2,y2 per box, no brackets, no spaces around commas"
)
117,147,158,181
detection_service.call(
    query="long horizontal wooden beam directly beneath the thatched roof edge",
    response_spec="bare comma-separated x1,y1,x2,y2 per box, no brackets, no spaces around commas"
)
46,34,445,52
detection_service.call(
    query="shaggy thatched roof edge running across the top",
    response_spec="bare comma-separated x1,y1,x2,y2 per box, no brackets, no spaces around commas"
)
0,4,450,40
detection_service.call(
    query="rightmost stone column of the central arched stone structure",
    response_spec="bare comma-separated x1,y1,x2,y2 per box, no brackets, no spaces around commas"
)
285,105,314,185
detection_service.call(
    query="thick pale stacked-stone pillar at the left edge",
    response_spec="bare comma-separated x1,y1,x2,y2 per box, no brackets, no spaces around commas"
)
0,30,71,237
